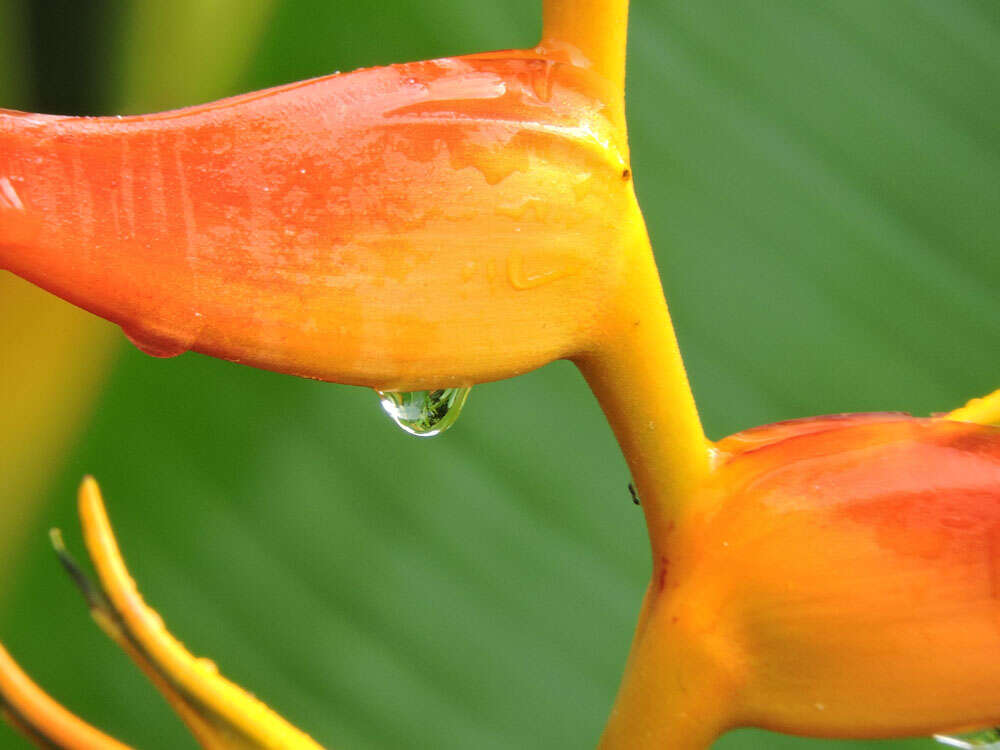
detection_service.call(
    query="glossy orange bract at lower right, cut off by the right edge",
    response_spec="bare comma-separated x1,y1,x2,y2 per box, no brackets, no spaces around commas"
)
680,414,1000,737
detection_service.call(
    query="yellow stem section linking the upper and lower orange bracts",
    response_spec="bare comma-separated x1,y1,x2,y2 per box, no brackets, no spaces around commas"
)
576,205,711,555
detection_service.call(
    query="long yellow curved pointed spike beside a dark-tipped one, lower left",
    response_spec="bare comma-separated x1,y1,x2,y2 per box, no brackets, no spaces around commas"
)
79,477,321,750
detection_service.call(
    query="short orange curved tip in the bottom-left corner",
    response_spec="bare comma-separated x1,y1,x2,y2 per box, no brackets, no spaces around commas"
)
0,645,130,750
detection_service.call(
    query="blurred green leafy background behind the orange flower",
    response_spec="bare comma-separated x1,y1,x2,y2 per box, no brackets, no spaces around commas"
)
0,0,1000,750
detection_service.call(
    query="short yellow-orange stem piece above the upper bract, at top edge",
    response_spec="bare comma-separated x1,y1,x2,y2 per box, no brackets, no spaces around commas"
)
542,0,628,104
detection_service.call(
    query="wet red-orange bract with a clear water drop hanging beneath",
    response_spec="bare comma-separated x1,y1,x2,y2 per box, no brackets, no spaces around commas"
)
0,51,637,389
